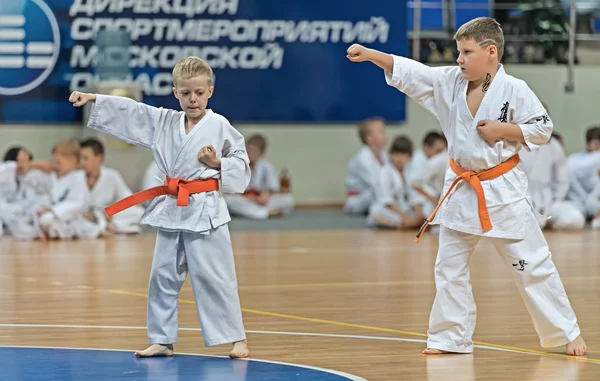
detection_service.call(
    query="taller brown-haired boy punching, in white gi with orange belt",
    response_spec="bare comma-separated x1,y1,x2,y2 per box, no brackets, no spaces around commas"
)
347,17,587,355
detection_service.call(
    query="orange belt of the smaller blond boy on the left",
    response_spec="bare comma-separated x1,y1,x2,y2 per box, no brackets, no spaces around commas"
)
104,176,219,217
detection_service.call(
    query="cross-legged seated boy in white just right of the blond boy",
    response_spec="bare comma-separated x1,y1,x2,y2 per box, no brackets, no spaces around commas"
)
225,135,294,220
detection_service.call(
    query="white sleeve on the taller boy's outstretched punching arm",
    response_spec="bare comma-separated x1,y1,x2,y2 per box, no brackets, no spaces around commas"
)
384,55,458,120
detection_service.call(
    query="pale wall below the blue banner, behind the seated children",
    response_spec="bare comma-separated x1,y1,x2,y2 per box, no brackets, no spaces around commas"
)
0,65,600,204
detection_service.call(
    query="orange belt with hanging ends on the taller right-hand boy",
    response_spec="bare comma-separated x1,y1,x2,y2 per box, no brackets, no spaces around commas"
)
415,154,520,243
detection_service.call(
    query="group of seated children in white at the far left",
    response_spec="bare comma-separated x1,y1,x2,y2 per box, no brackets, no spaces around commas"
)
0,138,144,240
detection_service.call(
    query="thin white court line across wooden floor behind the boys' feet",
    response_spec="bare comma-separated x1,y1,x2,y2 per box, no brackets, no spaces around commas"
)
0,324,600,364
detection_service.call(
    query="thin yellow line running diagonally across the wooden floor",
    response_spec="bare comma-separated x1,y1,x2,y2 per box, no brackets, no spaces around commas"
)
110,290,600,364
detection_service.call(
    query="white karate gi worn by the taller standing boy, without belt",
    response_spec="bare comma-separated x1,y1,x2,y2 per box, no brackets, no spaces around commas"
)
385,56,580,353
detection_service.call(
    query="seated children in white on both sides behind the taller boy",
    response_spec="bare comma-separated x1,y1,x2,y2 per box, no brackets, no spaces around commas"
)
344,118,600,230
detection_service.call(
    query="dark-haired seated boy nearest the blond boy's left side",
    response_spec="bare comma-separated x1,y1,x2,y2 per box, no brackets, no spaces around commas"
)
81,138,144,235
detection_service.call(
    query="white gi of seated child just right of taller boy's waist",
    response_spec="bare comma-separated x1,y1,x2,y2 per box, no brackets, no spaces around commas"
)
520,138,585,230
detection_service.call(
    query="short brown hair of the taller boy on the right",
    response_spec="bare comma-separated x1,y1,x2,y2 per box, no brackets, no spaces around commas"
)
454,17,504,62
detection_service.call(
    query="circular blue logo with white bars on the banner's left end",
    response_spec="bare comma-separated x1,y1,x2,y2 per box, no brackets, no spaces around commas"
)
0,0,60,95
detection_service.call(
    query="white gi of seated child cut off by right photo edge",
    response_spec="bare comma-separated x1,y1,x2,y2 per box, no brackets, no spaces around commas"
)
567,151,600,217
